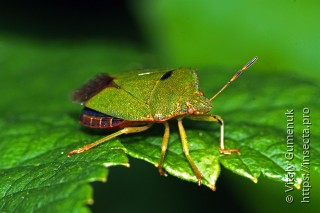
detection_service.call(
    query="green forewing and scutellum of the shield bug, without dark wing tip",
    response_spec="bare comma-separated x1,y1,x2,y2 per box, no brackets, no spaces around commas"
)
85,70,170,121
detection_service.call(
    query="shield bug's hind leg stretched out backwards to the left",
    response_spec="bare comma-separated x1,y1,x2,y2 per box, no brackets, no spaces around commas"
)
68,123,152,157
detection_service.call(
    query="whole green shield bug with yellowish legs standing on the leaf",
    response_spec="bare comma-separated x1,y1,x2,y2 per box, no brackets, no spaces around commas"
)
68,57,258,185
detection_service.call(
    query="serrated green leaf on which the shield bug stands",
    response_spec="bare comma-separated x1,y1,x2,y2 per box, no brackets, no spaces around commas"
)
0,35,320,212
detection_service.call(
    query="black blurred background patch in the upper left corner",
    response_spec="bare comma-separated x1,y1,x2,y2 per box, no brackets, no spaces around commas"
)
0,0,144,44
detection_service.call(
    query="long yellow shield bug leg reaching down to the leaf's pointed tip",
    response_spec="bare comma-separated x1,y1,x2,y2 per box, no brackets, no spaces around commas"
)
178,118,202,186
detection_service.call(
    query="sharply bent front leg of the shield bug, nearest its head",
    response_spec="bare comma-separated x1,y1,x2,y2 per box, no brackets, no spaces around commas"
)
186,115,240,154
